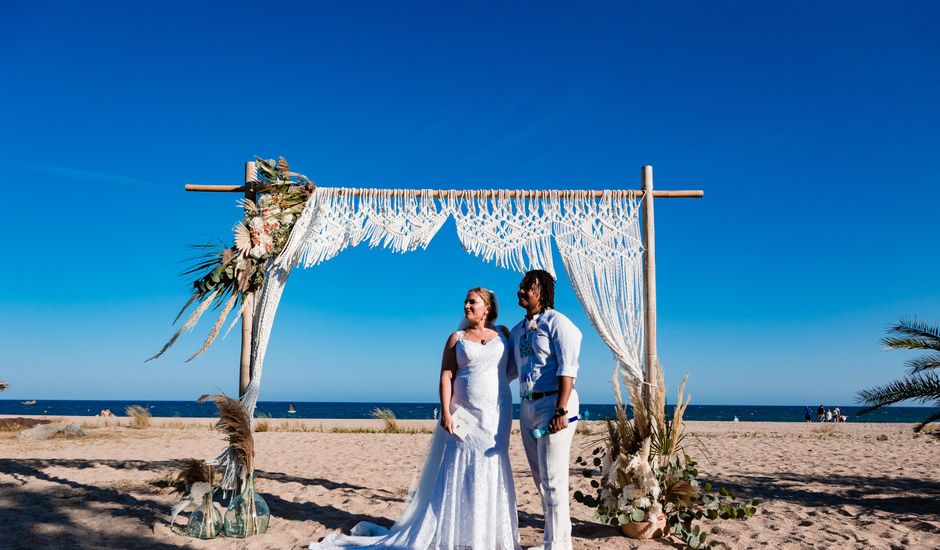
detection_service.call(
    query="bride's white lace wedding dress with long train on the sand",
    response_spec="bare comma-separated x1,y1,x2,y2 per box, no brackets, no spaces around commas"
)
310,331,520,550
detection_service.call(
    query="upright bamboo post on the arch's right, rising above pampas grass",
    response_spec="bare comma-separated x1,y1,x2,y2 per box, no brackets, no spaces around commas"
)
640,166,657,406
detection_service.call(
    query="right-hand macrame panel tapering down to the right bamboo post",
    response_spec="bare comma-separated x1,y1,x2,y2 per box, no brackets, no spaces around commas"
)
553,191,643,383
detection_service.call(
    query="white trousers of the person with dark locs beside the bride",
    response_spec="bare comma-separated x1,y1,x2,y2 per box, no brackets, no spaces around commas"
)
519,389,580,550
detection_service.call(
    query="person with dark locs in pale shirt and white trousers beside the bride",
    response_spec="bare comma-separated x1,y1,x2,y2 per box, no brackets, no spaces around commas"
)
509,269,581,550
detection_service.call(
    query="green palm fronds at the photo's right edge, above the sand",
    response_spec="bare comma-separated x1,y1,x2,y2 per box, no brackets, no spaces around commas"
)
858,319,940,437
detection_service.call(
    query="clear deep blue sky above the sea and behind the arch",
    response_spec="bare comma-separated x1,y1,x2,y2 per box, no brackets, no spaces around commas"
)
0,1,940,405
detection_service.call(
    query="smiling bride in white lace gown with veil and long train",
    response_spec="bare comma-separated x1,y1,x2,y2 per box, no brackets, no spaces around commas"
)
310,288,516,550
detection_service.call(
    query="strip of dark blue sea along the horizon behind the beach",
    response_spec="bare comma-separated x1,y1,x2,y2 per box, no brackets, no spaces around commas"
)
0,399,940,422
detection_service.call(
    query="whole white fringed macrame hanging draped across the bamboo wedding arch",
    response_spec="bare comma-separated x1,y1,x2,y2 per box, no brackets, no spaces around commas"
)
216,187,643,487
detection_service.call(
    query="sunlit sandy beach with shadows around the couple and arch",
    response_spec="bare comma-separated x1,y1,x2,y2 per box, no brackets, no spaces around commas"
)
0,417,940,549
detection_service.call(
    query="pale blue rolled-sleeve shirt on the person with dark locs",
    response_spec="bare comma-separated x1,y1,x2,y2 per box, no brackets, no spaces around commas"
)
509,309,581,397
